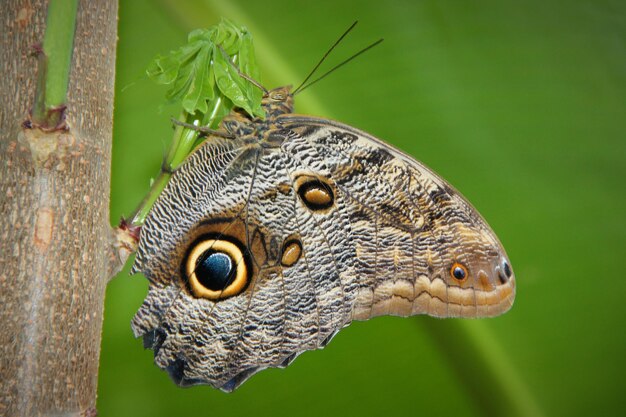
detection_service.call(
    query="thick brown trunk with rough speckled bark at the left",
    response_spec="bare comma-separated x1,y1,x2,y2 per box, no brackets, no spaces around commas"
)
0,0,117,416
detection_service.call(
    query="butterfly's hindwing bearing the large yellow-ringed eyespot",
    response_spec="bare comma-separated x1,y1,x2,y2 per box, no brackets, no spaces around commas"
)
132,132,358,391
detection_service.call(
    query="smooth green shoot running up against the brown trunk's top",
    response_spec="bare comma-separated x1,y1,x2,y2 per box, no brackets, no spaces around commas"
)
32,0,78,128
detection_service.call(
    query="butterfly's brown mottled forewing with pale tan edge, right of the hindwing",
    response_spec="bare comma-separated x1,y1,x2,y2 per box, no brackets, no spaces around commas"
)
281,115,515,319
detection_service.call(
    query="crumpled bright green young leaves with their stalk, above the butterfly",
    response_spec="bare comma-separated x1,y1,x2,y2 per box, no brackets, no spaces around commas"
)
131,19,264,226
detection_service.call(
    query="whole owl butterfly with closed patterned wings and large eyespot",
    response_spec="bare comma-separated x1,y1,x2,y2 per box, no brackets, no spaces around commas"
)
132,27,515,392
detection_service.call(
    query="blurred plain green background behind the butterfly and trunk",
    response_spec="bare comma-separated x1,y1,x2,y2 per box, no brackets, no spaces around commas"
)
98,0,626,417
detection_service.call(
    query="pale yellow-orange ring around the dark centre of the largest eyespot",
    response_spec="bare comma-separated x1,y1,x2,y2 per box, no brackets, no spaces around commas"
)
185,239,248,300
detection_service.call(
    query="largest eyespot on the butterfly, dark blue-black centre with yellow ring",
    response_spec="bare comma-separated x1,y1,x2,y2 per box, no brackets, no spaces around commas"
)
183,236,252,300
